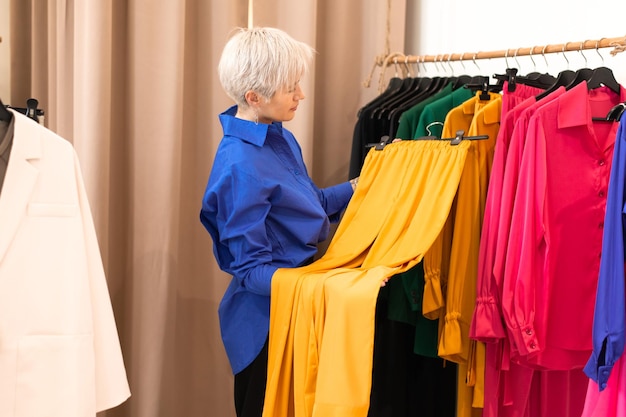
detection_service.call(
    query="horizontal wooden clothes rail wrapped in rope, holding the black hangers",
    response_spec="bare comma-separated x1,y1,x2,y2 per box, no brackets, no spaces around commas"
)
364,36,626,92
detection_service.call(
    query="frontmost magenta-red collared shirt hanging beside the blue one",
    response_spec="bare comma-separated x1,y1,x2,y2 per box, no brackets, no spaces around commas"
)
503,82,626,370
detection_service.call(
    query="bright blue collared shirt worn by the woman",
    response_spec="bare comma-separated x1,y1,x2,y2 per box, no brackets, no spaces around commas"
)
200,106,352,374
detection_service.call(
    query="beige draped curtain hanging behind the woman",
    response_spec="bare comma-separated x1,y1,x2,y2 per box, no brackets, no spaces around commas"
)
11,0,405,417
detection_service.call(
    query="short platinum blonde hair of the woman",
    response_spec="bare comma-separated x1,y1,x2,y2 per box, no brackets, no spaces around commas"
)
218,27,314,106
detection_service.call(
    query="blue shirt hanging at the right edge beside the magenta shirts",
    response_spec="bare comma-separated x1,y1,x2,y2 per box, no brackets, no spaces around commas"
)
585,113,626,391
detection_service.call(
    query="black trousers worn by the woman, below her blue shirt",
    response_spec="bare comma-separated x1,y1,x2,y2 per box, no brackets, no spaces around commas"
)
235,341,267,417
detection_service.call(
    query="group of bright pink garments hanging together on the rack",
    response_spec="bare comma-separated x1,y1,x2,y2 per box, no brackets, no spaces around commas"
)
470,69,626,417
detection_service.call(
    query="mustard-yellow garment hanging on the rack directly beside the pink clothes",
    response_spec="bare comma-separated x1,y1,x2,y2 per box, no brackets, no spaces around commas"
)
439,93,502,417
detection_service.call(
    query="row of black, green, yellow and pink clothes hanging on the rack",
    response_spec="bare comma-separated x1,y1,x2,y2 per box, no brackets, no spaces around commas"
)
350,52,626,417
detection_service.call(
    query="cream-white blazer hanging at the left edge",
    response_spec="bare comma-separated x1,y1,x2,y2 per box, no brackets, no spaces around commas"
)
0,111,130,417
